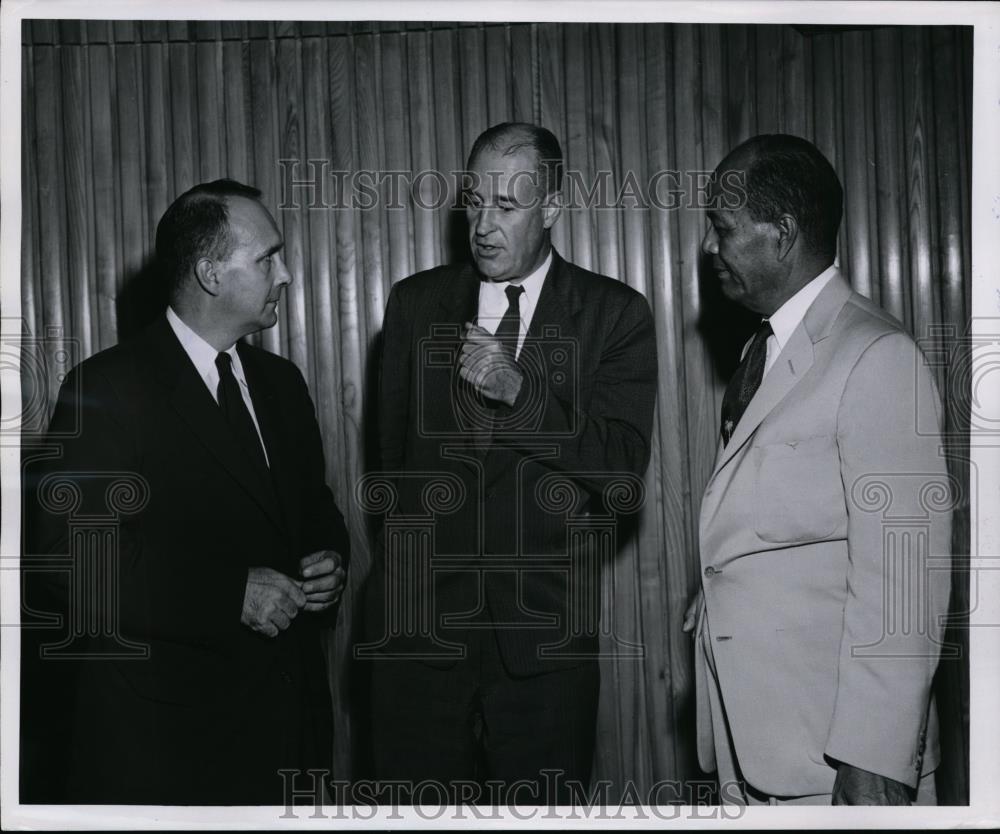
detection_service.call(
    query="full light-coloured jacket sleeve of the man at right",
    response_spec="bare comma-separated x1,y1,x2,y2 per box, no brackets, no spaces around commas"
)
826,333,951,787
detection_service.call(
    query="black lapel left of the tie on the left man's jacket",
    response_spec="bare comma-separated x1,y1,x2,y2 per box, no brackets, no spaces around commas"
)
151,318,284,529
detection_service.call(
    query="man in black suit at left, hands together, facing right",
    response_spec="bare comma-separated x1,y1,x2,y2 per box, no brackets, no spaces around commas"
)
22,180,348,805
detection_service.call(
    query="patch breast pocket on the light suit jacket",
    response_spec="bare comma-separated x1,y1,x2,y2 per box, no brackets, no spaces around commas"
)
753,435,847,544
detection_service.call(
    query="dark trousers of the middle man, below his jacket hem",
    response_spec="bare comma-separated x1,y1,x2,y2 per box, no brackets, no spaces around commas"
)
372,629,599,805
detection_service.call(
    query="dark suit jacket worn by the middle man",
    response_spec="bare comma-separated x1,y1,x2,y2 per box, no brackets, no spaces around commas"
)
367,255,656,675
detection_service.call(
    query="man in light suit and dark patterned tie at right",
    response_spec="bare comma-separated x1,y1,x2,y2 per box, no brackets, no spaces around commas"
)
685,135,951,804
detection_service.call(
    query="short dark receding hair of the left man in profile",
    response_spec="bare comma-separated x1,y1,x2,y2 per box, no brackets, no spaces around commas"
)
156,179,260,297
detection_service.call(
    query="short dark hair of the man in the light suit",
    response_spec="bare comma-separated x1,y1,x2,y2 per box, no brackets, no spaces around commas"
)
729,133,844,261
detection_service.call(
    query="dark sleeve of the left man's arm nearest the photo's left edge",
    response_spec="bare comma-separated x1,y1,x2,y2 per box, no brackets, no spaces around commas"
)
28,365,247,644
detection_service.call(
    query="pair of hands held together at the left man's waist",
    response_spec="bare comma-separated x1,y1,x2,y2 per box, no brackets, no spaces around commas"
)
240,550,346,637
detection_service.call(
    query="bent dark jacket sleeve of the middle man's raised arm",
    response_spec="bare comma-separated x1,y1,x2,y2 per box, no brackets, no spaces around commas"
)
499,293,657,481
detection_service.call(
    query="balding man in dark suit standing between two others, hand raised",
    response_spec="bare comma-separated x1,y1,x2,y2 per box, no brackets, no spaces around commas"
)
360,123,656,803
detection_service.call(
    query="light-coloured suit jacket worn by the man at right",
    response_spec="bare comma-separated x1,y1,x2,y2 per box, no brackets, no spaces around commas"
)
696,274,954,796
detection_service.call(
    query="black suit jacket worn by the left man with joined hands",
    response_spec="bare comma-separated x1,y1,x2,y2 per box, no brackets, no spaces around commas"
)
21,318,348,804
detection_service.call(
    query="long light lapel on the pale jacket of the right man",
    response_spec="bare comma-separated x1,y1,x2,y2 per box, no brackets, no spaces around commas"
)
715,272,852,473
